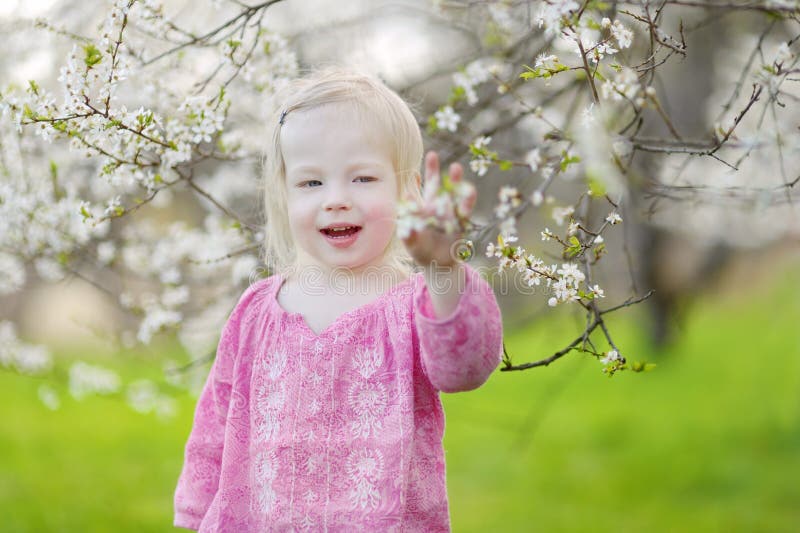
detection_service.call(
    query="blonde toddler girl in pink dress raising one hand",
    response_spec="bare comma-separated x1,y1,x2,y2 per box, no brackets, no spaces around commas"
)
175,69,502,533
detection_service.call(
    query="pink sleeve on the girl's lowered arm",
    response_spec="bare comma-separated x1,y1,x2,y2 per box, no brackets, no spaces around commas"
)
174,280,253,530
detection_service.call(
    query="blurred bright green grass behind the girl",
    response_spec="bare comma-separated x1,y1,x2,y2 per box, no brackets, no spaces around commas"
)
0,272,800,532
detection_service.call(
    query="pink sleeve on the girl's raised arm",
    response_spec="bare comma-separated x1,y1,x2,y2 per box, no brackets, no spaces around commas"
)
414,264,503,392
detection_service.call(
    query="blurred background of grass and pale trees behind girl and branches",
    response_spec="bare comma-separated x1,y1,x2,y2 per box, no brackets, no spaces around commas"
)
0,0,800,532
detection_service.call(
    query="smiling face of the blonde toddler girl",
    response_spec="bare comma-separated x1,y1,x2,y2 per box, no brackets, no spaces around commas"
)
281,105,398,278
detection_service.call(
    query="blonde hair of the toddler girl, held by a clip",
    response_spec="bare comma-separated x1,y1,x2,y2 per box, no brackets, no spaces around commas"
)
263,67,422,273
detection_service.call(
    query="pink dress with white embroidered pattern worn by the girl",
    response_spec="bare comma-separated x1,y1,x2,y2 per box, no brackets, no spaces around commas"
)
175,266,502,533
